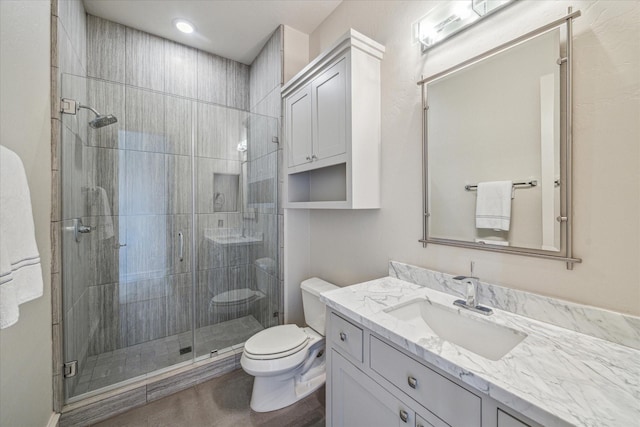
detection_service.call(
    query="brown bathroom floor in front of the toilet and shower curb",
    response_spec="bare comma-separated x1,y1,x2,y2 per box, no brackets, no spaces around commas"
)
94,369,325,427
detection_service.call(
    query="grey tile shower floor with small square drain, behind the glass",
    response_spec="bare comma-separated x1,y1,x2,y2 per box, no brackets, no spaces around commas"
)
73,316,263,396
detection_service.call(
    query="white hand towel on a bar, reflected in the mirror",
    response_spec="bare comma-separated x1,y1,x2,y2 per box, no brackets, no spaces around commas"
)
476,181,513,231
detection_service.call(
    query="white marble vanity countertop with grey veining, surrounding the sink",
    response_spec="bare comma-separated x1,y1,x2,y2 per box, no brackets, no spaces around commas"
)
321,277,640,427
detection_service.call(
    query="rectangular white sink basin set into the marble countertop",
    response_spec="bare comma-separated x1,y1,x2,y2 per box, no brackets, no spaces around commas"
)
385,298,527,360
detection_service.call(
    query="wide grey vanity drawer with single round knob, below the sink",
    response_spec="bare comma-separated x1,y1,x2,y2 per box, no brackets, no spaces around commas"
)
370,336,481,427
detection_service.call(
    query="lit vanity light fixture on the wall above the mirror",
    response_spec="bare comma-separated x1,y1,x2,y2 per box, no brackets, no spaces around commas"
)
413,0,516,52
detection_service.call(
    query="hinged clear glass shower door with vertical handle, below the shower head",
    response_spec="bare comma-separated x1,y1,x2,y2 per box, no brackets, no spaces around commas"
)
61,75,193,399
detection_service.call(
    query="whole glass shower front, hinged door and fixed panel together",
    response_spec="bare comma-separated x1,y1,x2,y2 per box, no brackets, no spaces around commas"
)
61,74,282,403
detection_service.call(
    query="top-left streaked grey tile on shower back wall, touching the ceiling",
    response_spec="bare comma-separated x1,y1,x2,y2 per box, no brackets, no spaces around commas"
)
87,15,126,83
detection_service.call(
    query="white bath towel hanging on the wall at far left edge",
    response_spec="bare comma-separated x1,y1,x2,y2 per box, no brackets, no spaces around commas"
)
0,146,43,330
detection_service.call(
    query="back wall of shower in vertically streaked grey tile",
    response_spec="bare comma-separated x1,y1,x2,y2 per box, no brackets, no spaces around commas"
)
87,16,258,354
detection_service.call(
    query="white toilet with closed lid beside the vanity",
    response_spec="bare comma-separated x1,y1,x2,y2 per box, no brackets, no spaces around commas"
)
240,278,338,412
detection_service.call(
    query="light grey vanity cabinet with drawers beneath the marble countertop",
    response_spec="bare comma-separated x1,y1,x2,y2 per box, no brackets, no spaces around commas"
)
326,309,542,427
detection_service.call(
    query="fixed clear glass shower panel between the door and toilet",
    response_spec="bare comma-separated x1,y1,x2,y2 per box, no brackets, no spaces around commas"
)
195,103,281,362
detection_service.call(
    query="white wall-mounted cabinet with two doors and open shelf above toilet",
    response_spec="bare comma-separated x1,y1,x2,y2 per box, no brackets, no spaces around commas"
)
282,30,384,209
